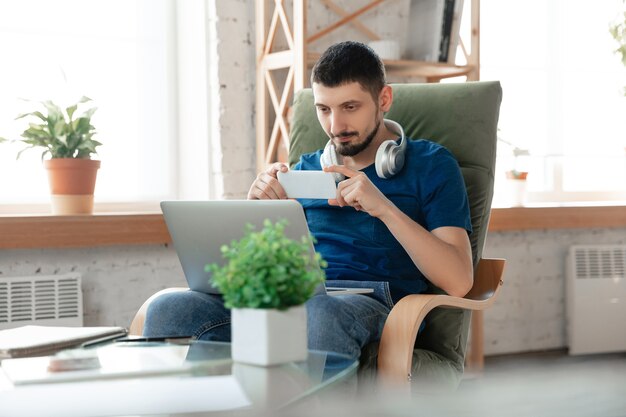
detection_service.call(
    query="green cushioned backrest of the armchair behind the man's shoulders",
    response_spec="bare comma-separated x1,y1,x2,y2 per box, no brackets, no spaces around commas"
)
289,81,502,266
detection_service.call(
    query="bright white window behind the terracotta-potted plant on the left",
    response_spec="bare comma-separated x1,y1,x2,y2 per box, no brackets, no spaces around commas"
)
0,0,178,204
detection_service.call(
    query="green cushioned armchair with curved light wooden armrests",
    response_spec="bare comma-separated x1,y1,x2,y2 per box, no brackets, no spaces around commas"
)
130,82,504,389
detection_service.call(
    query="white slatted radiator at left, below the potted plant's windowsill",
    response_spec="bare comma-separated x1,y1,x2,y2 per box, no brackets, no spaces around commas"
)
0,273,83,330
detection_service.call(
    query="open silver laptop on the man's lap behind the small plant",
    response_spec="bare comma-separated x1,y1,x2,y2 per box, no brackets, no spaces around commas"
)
161,200,373,295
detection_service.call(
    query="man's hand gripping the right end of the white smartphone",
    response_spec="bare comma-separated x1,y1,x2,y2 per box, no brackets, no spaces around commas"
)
324,165,393,217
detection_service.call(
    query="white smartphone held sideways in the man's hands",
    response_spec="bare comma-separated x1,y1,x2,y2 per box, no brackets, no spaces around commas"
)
278,171,337,200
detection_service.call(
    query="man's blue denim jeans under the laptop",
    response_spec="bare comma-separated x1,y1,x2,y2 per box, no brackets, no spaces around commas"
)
143,281,393,359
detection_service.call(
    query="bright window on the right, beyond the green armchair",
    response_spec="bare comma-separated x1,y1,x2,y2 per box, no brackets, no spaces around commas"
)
481,0,626,203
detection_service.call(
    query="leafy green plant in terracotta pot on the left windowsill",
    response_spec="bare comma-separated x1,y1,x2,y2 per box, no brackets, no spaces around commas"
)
3,97,101,215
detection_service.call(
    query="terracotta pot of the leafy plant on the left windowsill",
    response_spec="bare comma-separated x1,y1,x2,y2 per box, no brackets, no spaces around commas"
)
44,158,100,215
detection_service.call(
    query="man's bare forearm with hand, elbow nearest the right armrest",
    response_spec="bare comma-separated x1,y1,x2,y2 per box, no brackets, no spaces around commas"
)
324,165,473,297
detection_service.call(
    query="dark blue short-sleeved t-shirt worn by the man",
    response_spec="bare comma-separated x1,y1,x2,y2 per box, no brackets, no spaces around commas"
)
294,140,472,303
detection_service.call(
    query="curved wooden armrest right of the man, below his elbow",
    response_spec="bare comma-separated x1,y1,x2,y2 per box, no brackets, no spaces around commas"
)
378,259,505,384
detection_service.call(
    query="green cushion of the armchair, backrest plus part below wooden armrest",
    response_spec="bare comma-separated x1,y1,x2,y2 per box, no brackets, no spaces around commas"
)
289,82,502,386
